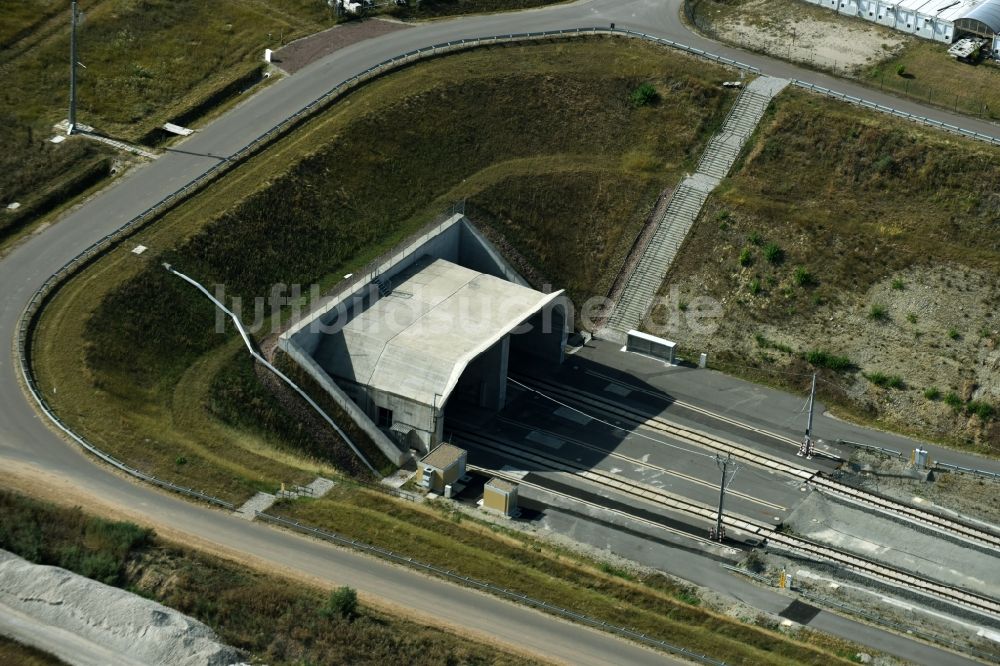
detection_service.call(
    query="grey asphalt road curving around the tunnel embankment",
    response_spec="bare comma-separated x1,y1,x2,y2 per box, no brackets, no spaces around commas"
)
0,0,996,666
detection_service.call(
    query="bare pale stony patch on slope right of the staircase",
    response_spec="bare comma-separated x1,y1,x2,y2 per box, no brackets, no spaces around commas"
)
663,260,1000,455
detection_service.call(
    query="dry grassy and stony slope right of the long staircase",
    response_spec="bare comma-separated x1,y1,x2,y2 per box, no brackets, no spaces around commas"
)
656,91,1000,454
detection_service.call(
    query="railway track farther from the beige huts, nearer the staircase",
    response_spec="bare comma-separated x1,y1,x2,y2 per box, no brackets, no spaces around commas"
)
511,377,1000,551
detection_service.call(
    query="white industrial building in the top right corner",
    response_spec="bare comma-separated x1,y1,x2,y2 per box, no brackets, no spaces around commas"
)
806,0,1000,49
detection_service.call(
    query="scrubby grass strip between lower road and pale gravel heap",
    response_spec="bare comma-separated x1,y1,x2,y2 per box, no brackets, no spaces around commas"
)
0,490,534,664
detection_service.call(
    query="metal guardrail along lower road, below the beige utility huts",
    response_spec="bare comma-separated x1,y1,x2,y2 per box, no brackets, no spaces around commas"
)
256,511,726,666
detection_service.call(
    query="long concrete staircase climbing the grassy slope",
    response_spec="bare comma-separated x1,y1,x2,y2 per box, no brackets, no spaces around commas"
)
599,76,788,342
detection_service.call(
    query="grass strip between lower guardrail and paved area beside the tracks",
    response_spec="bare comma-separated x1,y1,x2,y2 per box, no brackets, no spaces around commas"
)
272,485,872,664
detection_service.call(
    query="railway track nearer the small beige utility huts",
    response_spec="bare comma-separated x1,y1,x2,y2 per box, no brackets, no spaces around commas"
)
450,427,1000,619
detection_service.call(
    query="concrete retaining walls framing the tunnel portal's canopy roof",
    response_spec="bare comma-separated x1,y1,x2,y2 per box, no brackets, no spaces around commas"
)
278,214,536,456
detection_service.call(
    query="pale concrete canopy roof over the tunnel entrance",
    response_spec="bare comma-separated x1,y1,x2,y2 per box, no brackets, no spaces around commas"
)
317,259,563,407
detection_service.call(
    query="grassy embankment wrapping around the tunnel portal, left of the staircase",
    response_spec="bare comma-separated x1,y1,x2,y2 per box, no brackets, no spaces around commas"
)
36,39,732,501
